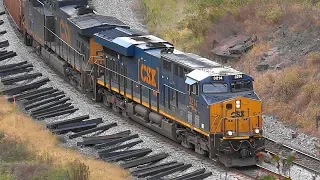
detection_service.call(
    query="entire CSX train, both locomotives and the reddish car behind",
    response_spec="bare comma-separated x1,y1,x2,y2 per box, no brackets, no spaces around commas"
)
3,0,265,167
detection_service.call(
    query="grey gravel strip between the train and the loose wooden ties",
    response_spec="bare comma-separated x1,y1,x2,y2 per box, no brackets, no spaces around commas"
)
0,0,241,179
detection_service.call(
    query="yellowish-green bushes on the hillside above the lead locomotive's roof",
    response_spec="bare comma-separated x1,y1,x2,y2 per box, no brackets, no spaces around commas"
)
139,0,320,55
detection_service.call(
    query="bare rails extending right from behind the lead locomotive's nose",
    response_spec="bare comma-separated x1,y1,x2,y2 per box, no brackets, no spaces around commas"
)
265,138,320,174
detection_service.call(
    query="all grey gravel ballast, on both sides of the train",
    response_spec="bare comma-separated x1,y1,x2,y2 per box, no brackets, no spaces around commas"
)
0,0,315,179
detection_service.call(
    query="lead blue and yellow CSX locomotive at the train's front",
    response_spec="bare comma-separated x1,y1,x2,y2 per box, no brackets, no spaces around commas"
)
94,28,264,166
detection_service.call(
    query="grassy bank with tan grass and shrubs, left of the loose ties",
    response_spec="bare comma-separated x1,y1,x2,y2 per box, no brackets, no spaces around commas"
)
0,96,131,180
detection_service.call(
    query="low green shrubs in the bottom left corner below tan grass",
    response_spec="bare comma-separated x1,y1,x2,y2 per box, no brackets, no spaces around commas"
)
0,132,89,180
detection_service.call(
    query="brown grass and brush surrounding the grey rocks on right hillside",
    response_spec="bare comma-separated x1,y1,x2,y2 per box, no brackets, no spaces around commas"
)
201,0,320,135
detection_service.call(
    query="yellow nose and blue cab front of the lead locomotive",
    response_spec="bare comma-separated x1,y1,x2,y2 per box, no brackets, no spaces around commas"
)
186,68,264,167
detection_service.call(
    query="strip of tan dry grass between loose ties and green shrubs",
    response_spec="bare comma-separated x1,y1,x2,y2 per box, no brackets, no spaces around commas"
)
0,97,131,180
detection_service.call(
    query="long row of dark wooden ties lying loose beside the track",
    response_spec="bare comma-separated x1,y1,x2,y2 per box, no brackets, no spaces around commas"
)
0,13,212,180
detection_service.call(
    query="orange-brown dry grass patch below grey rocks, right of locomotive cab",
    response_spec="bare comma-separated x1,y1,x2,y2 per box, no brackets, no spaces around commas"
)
255,65,320,135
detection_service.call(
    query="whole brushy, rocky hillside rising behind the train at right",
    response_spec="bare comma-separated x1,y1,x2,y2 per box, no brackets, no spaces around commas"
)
140,0,320,135
